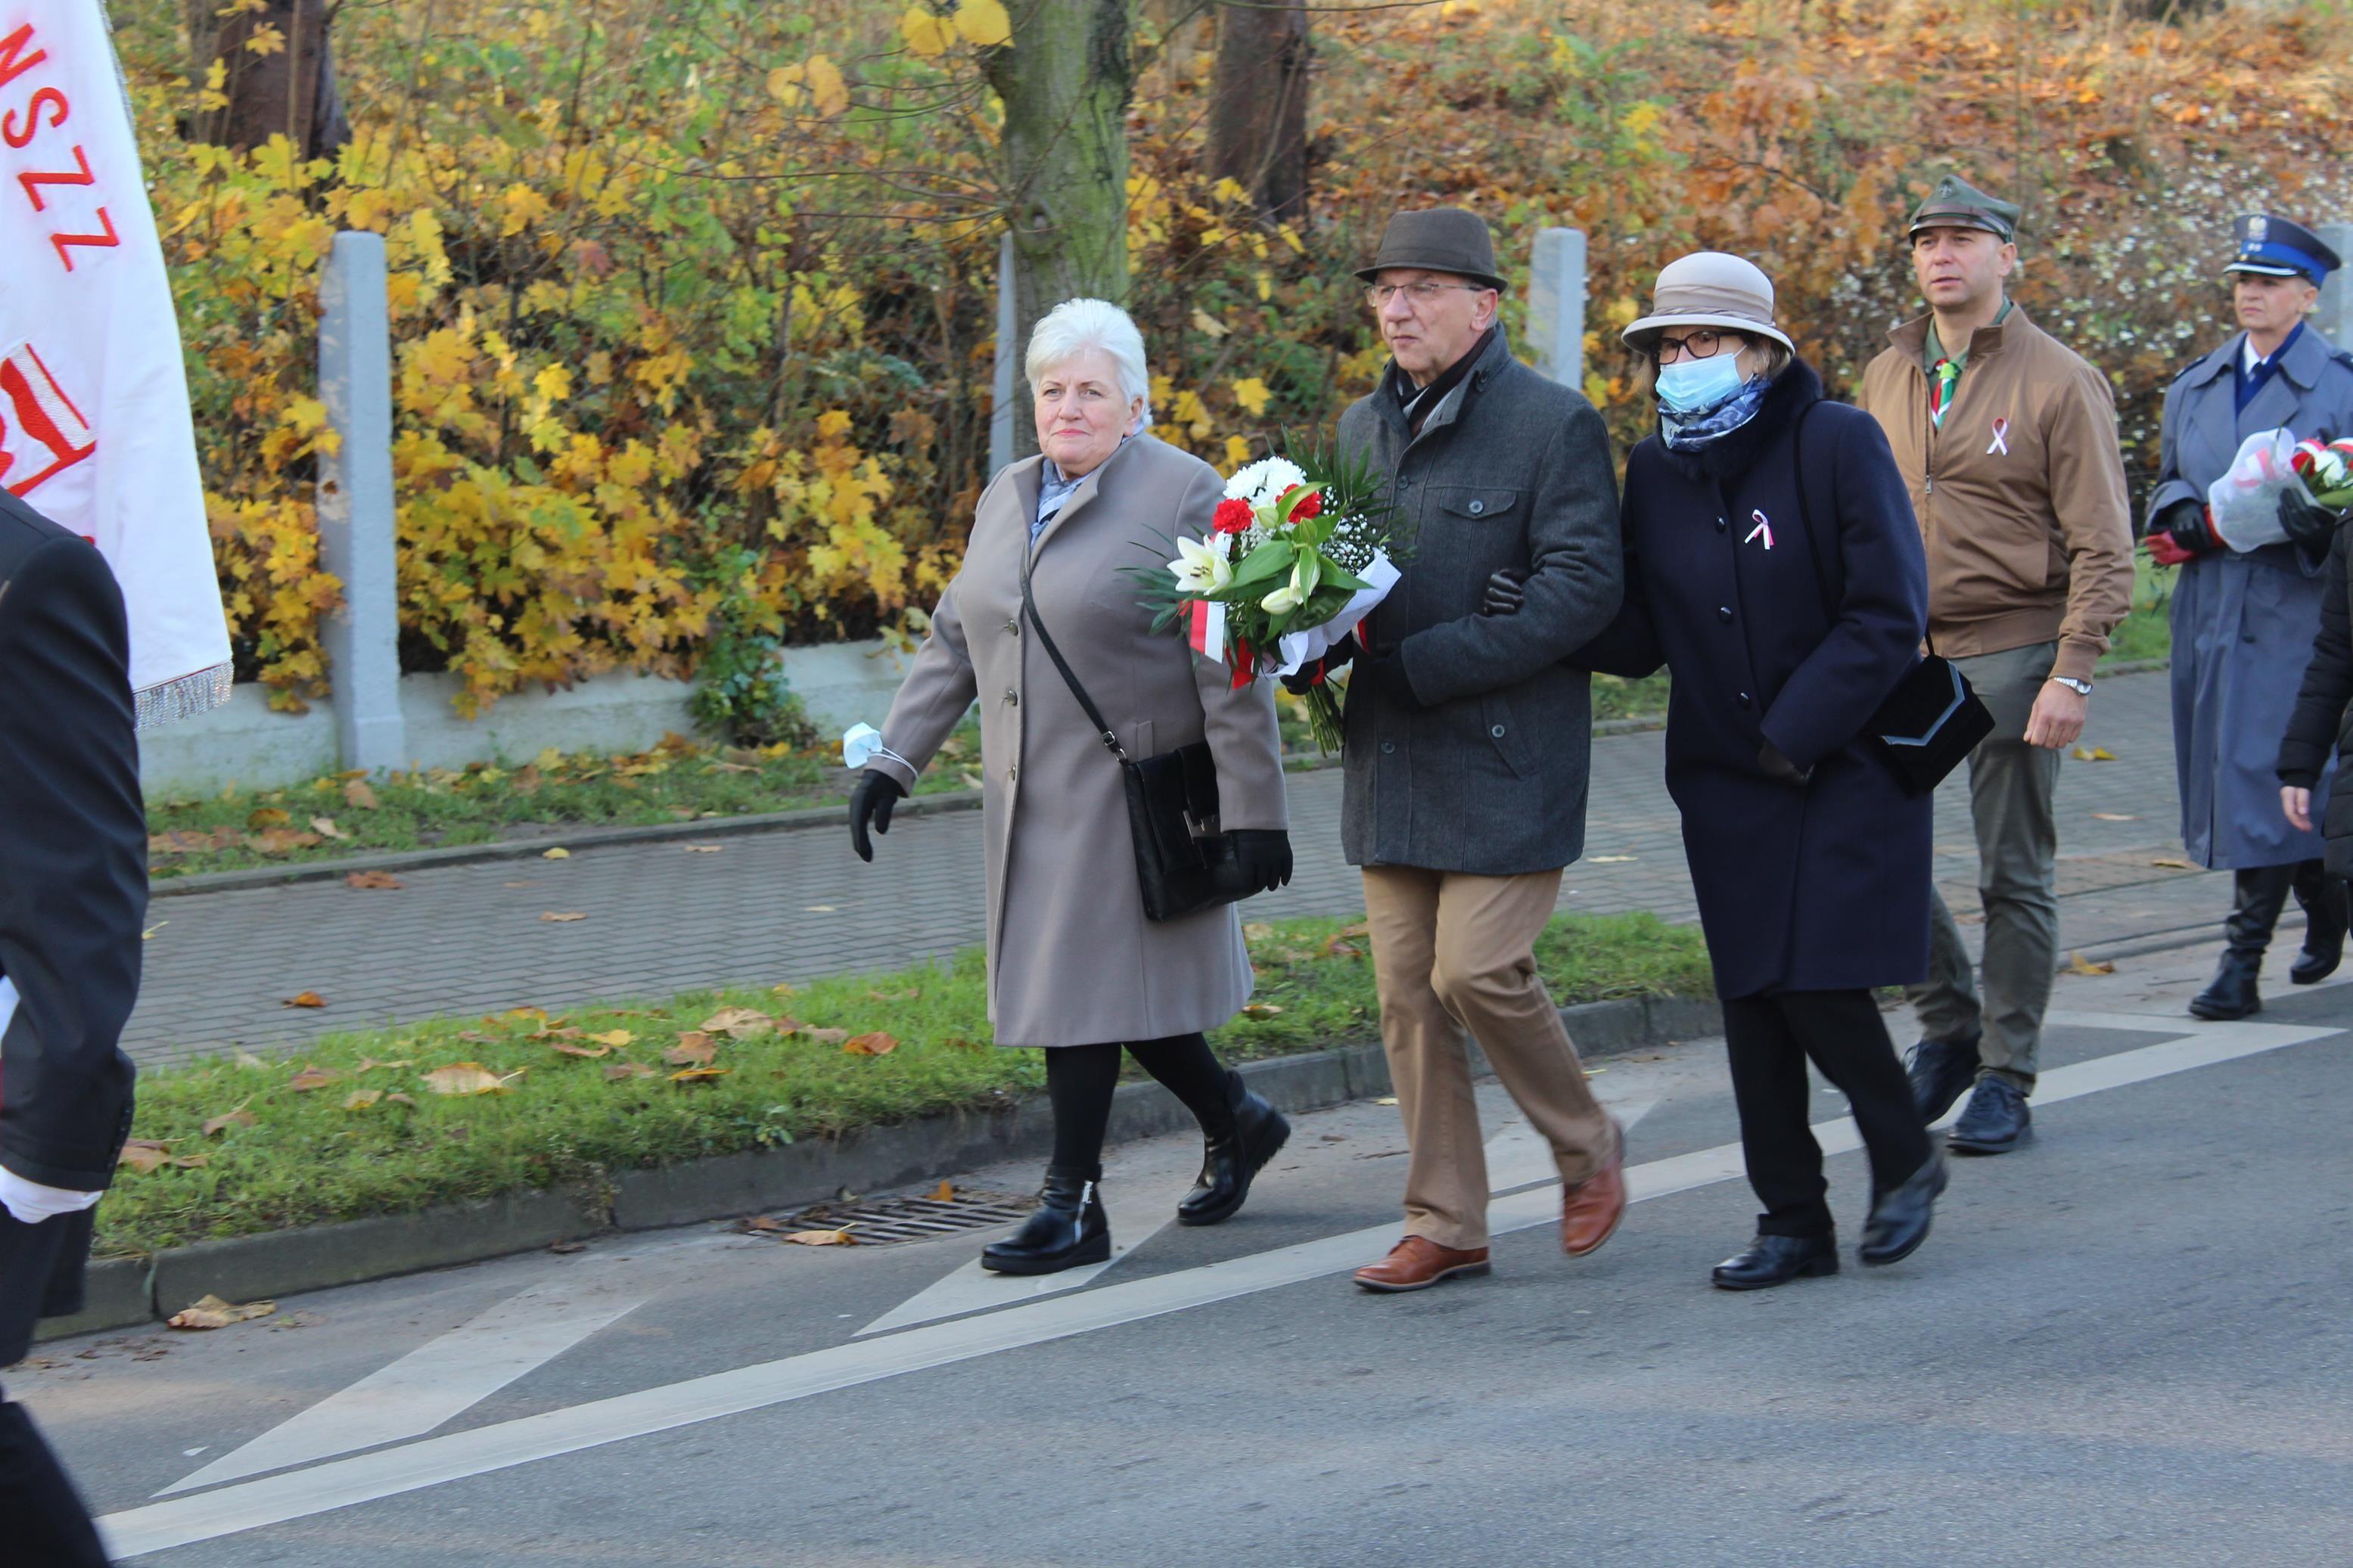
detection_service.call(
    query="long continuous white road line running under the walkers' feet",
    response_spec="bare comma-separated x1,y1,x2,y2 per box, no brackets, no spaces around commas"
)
99,1014,2346,1559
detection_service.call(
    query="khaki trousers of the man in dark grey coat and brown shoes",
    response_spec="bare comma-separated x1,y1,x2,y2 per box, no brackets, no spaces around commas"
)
1365,865,1617,1248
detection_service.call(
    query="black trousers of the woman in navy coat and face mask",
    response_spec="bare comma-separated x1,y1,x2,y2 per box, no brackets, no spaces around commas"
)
1725,989,1929,1237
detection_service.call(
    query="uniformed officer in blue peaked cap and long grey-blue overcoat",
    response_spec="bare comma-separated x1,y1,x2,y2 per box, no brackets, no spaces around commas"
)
2148,214,2353,1018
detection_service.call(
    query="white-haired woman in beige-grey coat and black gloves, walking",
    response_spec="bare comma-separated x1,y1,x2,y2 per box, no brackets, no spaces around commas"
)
850,299,1292,1275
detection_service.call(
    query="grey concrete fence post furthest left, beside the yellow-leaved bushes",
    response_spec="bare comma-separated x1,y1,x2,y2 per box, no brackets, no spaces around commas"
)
318,233,407,771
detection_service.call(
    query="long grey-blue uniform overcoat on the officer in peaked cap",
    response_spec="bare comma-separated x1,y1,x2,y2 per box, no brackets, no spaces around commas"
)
2148,322,2353,868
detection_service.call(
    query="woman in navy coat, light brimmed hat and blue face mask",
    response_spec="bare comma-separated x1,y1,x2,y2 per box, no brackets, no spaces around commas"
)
1574,252,1944,1290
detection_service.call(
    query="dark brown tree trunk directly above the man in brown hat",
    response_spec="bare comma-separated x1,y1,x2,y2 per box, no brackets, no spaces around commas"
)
1210,0,1308,223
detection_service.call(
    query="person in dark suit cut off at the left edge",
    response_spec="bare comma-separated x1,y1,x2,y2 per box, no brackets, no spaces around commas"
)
0,492,146,1568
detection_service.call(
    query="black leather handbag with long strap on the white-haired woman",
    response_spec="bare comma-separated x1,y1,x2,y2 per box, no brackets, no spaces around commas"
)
1021,564,1259,919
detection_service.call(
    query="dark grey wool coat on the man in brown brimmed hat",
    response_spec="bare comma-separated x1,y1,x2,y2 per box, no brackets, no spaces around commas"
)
1339,327,1626,877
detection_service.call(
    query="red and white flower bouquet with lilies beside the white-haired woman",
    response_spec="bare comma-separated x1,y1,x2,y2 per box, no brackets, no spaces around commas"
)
1136,452,1407,753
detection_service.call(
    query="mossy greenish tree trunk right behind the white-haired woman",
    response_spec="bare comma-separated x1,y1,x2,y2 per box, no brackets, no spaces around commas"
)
988,0,1134,458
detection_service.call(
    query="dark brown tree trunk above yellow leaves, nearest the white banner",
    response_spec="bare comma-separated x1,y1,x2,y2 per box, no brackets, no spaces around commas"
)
186,0,350,157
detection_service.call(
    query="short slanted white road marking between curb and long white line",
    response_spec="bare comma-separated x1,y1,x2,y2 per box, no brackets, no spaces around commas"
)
155,1279,647,1498
